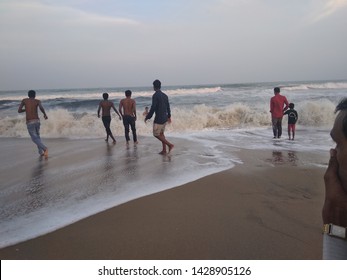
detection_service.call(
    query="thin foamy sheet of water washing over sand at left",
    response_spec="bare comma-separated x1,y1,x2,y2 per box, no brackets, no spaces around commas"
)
0,137,237,247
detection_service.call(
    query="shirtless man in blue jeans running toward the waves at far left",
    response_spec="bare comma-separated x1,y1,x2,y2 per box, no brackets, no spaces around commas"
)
18,90,48,158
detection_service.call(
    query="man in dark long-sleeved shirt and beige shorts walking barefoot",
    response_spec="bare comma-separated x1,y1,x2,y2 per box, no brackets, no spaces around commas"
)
145,80,174,155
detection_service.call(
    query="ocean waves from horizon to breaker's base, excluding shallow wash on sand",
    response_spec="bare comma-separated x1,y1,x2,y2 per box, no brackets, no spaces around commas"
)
0,81,347,139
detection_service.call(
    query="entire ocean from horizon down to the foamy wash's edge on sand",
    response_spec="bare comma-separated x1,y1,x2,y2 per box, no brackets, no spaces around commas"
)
0,81,347,247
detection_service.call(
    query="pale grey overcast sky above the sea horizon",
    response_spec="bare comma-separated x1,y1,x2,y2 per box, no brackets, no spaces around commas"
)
0,0,347,90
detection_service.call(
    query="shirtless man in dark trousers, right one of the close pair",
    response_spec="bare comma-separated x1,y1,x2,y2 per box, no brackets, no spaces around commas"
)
119,90,138,145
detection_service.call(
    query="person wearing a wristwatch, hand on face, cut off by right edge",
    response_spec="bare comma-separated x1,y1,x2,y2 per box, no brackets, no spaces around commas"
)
322,98,347,260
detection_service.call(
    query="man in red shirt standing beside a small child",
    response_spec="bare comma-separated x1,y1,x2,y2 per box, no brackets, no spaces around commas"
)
270,87,288,138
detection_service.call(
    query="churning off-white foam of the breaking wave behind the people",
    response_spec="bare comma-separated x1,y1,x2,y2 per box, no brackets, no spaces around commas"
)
0,99,335,138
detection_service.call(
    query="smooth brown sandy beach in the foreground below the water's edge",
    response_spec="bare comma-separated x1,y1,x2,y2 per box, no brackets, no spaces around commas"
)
0,140,328,260
